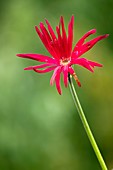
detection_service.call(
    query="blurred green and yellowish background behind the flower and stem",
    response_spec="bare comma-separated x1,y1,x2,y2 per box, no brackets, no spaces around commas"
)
0,0,113,170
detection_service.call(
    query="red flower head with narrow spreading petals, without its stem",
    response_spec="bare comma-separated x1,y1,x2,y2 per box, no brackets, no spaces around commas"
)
17,16,108,94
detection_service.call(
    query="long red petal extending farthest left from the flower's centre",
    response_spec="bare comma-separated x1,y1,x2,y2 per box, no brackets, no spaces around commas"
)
17,54,56,64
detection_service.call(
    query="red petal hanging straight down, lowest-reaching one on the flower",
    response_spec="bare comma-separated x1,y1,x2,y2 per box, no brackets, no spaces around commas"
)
55,68,62,95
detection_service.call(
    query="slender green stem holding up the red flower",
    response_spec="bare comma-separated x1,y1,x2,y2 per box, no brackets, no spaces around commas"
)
69,75,107,170
